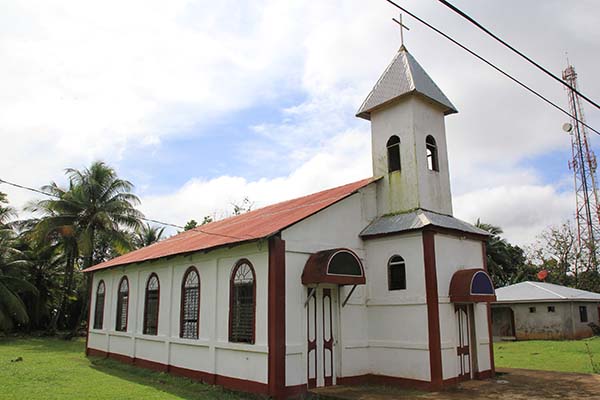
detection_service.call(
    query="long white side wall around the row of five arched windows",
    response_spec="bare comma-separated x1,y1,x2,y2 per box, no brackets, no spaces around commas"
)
88,242,268,383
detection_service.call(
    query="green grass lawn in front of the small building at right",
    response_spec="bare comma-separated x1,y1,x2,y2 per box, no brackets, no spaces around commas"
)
494,338,600,374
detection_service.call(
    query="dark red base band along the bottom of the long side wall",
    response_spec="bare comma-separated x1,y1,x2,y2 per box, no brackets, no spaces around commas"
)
88,348,270,395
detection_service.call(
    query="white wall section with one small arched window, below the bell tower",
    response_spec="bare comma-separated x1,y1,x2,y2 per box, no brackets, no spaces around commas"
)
366,233,430,381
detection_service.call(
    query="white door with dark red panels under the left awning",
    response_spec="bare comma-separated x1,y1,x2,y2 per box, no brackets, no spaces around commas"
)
306,287,339,388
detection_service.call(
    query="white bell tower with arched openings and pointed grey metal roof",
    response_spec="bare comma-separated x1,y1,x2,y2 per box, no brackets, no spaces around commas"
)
356,45,458,215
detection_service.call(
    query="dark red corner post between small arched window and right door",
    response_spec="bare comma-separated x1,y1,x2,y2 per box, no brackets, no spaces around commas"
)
423,230,443,387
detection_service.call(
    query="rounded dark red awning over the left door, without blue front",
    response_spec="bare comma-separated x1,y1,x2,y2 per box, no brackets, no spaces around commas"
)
302,248,366,285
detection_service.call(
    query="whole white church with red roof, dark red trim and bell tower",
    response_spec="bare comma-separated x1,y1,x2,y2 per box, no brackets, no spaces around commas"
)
86,47,495,399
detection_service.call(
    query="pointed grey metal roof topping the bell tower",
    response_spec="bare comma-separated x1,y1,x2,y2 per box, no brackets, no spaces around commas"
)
356,46,458,120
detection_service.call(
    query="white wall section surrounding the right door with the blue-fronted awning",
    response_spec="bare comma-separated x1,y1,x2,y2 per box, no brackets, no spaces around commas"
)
435,234,491,379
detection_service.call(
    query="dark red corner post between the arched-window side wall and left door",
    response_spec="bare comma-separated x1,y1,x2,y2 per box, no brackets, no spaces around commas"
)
267,236,288,398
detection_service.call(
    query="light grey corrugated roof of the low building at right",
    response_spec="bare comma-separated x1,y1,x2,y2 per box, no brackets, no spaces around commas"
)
496,281,600,303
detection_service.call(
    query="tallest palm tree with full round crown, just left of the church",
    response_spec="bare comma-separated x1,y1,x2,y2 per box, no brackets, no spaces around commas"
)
28,161,143,330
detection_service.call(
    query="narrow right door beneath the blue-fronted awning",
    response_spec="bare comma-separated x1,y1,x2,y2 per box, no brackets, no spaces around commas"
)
454,304,477,379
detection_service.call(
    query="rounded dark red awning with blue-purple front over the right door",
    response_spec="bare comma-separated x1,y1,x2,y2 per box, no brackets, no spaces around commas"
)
450,268,496,303
